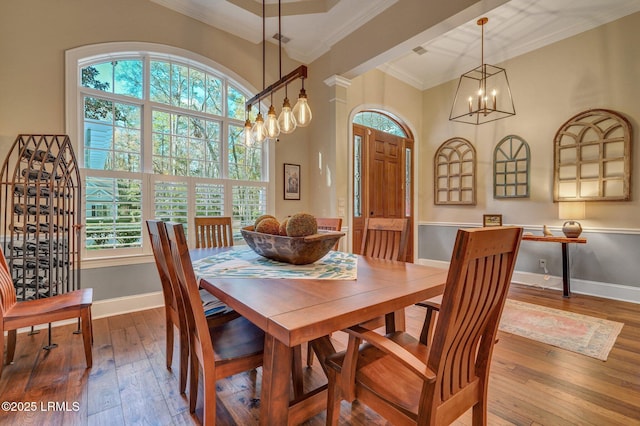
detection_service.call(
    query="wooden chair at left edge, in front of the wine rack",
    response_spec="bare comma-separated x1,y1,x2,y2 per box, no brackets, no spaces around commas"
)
0,250,93,376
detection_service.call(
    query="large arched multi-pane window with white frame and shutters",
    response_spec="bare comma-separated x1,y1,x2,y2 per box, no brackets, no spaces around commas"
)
67,43,272,257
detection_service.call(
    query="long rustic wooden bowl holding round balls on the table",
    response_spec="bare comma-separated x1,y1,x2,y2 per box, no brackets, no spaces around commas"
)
240,226,344,265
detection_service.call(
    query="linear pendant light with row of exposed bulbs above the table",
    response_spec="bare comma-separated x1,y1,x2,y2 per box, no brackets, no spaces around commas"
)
244,0,312,145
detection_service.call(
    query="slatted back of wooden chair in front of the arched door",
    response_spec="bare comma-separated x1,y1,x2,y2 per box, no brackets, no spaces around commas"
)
360,218,409,260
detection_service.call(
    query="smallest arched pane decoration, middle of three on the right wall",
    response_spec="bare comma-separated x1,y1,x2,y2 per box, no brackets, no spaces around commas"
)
493,135,530,198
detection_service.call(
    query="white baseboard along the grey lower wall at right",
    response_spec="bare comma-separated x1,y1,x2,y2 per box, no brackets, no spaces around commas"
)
416,259,640,304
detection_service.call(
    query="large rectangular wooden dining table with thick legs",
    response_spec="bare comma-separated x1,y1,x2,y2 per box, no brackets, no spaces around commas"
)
190,246,447,426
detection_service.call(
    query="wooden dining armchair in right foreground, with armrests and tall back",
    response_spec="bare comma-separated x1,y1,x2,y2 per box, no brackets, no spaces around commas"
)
327,227,522,426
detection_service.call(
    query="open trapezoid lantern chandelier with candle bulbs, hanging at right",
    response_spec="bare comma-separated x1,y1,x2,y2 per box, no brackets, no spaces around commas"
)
449,18,516,125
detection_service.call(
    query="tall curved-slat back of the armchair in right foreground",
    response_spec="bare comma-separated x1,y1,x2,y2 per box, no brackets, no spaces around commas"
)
423,227,522,424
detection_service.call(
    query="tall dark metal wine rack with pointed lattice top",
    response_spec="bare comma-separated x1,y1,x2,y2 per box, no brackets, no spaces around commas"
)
0,134,82,301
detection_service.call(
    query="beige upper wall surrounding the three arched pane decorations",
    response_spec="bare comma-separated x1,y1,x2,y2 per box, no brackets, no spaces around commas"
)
417,13,640,229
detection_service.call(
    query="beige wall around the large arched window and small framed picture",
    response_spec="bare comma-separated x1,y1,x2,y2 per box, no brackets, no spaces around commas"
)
0,0,307,214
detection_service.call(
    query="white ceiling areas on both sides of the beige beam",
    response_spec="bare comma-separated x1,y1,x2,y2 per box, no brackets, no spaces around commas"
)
151,0,640,90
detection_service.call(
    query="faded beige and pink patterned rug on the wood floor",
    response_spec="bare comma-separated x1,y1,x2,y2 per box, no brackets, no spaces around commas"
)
500,299,624,361
